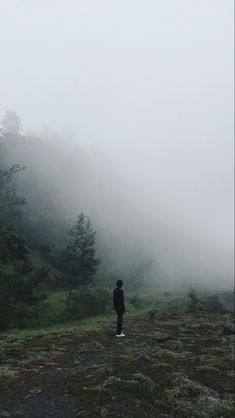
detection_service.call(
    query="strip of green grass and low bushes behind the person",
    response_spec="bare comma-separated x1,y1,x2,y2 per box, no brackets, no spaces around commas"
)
0,287,182,338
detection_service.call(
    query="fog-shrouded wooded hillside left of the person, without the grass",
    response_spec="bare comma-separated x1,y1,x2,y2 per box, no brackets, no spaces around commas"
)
0,111,151,329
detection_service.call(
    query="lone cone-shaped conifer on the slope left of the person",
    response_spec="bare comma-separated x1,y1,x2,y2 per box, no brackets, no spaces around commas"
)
62,213,100,300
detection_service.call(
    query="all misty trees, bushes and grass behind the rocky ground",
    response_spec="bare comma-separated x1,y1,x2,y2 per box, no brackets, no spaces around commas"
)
0,111,233,332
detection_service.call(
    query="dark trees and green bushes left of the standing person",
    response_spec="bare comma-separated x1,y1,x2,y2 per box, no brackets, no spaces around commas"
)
0,111,106,331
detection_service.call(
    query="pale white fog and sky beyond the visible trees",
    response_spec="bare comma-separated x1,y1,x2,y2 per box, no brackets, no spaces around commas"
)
0,0,234,287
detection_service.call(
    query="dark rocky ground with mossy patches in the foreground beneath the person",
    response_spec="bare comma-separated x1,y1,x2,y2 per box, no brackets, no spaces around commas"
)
0,313,234,418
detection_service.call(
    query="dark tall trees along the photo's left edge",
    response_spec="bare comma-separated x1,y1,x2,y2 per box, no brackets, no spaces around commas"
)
0,165,43,330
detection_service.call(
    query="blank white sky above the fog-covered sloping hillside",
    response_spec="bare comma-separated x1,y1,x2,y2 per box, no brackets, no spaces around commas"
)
0,0,234,286
